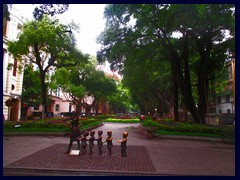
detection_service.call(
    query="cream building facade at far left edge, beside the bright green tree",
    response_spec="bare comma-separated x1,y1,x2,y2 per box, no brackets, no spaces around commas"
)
3,6,24,121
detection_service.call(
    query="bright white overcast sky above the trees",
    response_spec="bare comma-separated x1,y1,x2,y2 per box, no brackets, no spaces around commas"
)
13,4,106,56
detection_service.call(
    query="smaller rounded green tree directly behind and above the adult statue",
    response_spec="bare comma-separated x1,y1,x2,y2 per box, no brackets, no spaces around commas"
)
51,55,116,114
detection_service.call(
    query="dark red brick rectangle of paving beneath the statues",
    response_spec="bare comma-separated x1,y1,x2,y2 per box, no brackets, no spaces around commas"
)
6,144,156,173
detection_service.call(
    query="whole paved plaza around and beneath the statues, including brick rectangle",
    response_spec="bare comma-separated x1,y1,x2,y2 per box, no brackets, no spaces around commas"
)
3,123,235,176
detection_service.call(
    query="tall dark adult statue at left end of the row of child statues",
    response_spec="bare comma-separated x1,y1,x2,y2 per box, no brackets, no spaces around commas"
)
63,111,80,154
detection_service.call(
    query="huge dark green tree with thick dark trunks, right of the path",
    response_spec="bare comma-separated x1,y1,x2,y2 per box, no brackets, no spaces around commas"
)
98,4,235,123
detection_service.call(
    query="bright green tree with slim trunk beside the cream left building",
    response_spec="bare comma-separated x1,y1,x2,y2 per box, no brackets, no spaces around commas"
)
8,16,83,116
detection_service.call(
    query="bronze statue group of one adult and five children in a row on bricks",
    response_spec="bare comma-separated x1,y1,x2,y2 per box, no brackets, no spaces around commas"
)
64,113,128,157
